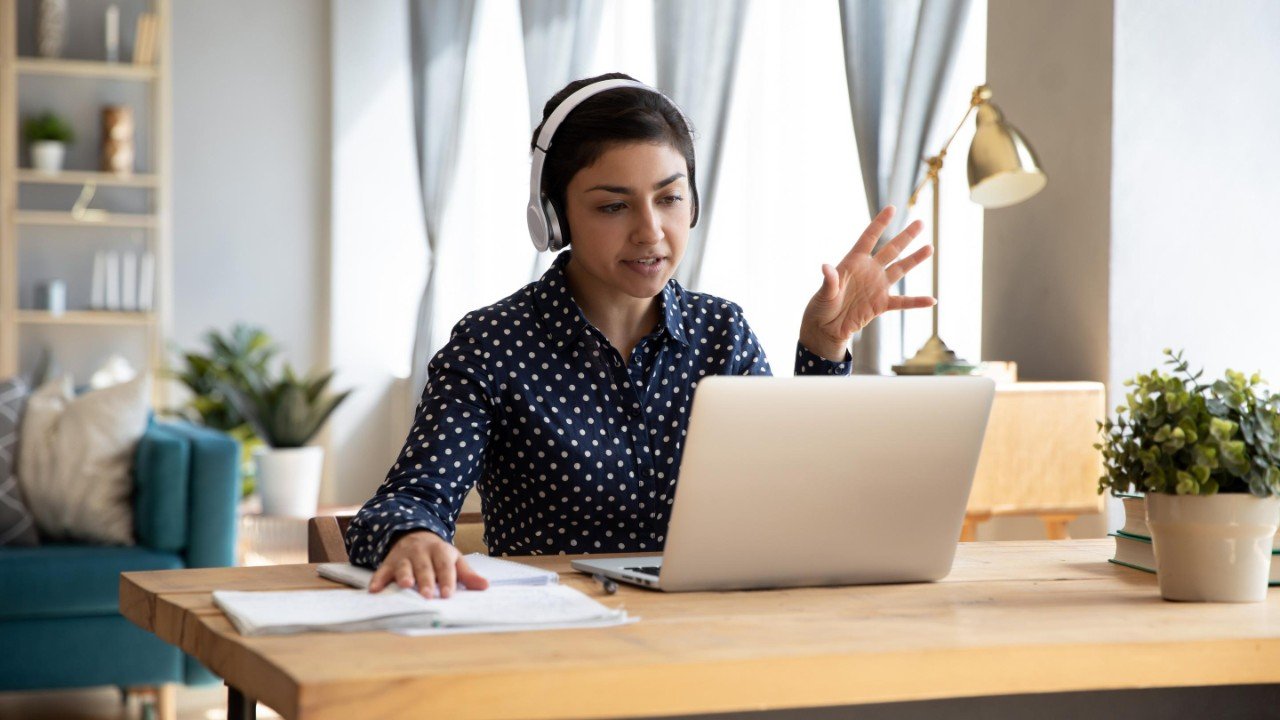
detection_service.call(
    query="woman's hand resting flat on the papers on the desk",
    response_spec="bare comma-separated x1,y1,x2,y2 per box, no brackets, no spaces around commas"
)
369,530,489,597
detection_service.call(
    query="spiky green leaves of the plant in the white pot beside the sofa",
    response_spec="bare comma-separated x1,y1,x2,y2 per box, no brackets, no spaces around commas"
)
224,365,351,447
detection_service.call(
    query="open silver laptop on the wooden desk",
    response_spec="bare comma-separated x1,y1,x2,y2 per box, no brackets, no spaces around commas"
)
572,377,996,592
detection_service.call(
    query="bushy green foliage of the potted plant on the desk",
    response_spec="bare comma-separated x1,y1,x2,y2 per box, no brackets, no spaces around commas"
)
1094,348,1280,497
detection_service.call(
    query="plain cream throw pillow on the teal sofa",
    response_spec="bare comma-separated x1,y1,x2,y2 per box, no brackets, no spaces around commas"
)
18,377,150,544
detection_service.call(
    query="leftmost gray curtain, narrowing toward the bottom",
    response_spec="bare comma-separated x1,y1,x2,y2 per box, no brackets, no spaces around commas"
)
410,0,475,397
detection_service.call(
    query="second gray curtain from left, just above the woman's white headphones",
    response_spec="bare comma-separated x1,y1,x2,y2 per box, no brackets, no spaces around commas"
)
520,0,604,281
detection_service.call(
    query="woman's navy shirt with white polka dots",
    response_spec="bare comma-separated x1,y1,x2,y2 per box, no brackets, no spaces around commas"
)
347,251,850,568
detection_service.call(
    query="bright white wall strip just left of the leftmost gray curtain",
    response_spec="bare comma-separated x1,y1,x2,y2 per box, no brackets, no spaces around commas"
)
321,0,426,505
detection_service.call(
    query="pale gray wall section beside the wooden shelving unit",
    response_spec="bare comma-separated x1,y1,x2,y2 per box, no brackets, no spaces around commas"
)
172,0,329,369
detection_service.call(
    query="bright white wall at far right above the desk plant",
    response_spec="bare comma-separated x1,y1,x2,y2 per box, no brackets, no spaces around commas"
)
1108,0,1280,397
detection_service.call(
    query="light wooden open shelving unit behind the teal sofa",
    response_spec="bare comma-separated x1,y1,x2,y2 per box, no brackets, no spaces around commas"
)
0,0,173,392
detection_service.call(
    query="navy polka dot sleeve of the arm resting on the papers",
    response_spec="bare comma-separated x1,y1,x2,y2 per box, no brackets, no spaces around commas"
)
346,318,493,568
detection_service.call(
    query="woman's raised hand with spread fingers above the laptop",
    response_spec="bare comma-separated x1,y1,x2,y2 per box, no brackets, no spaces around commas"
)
800,205,937,360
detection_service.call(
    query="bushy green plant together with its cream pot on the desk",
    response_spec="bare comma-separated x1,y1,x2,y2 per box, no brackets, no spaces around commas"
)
1096,348,1280,602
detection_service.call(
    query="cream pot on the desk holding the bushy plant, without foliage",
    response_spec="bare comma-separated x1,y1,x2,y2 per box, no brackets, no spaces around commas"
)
1147,492,1280,602
